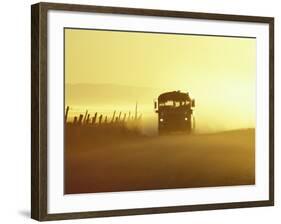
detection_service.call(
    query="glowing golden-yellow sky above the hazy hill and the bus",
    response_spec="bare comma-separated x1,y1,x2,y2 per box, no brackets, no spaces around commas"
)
65,29,256,130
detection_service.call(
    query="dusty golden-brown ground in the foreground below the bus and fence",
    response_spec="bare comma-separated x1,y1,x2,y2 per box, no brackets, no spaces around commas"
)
65,129,255,194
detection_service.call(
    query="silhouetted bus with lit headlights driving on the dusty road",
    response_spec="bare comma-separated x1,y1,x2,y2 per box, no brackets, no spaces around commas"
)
154,91,195,135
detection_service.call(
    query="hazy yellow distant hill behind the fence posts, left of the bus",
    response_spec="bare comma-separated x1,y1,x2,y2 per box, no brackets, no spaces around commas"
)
65,84,162,105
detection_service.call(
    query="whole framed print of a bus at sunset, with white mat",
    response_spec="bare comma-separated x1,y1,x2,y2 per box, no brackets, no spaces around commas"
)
31,3,274,221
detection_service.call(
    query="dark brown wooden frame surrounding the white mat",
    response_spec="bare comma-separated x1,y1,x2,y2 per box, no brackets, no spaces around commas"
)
31,3,274,221
